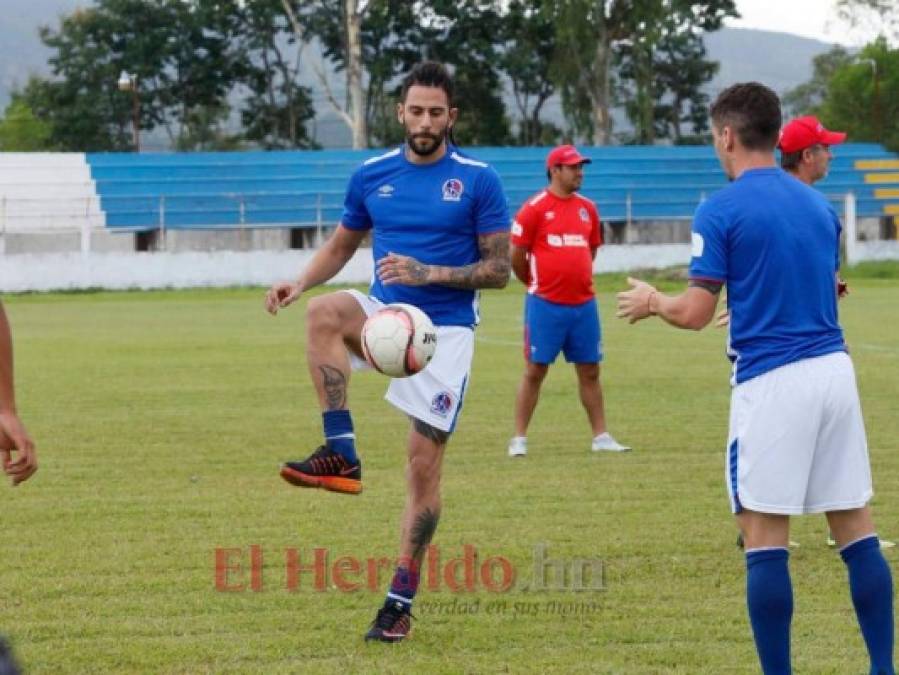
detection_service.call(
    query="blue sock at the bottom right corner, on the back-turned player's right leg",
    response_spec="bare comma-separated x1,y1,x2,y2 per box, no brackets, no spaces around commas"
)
840,534,896,675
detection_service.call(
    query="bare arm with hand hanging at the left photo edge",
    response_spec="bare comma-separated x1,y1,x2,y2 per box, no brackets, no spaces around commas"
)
0,304,37,485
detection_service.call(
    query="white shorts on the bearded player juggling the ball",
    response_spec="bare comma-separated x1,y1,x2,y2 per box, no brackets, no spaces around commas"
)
343,290,474,432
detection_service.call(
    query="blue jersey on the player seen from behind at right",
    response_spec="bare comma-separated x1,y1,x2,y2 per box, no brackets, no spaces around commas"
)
690,167,845,384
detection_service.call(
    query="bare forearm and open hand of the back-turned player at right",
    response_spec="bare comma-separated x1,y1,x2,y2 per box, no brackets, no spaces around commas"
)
617,278,721,330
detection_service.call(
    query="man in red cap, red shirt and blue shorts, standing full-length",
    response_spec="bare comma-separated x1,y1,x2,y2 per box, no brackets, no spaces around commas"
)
509,145,630,457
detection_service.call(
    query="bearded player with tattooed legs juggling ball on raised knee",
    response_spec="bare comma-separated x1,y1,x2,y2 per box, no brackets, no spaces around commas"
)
265,62,510,642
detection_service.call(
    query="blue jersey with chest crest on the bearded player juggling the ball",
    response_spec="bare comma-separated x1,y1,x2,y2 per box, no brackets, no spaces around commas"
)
341,146,511,326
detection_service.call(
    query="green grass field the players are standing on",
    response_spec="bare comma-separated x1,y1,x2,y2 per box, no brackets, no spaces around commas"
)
0,266,899,674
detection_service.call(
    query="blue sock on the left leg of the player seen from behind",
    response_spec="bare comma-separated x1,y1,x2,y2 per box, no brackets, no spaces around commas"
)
746,548,793,675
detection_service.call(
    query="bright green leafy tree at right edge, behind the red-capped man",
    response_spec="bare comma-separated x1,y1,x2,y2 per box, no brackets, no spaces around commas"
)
819,37,899,151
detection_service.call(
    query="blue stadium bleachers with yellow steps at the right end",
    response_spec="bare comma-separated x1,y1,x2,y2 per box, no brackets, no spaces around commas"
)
87,143,899,230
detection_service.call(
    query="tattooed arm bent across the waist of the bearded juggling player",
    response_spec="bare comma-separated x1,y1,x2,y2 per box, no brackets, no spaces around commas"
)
378,232,511,289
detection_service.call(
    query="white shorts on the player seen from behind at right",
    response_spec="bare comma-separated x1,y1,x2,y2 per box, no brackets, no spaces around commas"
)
725,352,873,515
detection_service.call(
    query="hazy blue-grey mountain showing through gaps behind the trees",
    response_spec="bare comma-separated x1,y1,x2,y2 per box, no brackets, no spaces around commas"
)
0,5,831,150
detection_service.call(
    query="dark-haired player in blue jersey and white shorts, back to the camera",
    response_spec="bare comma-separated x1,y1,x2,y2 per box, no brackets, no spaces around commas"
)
618,82,894,675
